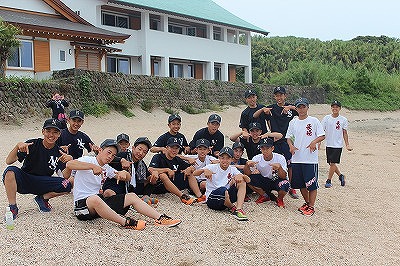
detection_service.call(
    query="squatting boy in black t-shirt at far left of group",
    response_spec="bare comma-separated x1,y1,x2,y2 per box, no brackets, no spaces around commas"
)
3,119,72,219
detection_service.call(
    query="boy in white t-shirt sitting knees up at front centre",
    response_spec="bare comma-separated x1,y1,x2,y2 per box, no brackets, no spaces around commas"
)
193,147,250,221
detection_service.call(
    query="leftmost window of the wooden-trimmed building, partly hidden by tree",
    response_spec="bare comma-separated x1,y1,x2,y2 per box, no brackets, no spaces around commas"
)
7,41,33,68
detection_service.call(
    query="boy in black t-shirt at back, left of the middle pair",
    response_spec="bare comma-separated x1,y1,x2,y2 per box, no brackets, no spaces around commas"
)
150,114,190,154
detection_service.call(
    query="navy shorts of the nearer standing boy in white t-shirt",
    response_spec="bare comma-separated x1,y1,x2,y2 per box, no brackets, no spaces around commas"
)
291,163,318,191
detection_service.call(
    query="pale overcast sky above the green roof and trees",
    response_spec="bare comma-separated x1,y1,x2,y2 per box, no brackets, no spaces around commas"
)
213,0,400,41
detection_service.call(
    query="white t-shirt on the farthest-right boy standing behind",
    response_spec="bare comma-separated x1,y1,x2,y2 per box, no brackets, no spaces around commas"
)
322,115,349,148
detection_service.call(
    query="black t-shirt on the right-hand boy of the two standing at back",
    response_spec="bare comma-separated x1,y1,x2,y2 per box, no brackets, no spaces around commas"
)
266,103,299,141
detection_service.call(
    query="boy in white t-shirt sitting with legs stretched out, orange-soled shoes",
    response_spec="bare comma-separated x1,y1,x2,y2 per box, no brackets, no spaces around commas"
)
66,139,181,230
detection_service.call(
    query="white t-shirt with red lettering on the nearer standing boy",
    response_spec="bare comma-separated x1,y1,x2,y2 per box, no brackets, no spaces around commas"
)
286,116,325,164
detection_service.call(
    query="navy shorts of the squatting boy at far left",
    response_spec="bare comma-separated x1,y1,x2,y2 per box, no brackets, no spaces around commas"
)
3,166,72,195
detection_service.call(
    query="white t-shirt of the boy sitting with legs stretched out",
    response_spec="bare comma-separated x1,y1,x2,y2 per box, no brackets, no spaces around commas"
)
73,156,116,201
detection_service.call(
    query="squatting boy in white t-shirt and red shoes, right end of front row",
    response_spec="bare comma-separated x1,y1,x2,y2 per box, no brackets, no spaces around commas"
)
244,138,290,208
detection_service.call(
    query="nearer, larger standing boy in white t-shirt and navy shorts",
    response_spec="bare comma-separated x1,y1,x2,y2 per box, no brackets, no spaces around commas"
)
286,98,325,216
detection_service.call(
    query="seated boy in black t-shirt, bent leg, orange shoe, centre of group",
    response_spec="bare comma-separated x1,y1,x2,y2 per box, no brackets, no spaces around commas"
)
149,138,197,205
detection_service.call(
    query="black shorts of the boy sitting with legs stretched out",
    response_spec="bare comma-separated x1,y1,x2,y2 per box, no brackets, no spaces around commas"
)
74,194,129,221
